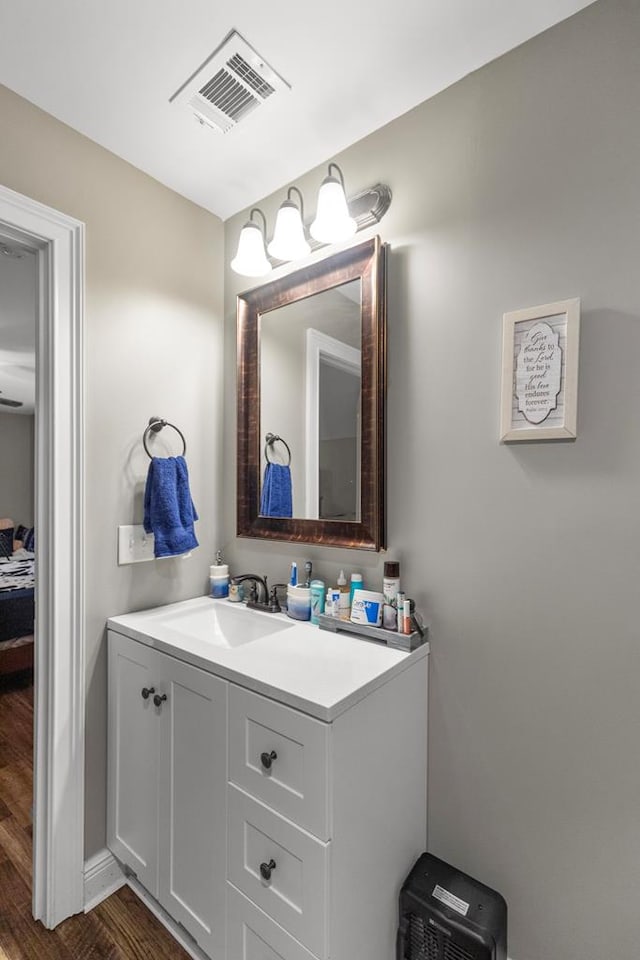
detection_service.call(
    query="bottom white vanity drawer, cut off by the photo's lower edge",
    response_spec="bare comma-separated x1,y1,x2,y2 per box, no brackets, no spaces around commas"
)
227,883,315,960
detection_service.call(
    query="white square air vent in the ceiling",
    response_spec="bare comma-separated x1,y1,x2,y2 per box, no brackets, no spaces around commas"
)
170,30,289,133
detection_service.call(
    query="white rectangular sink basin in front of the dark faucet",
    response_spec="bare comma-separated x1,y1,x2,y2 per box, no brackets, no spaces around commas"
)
145,601,293,648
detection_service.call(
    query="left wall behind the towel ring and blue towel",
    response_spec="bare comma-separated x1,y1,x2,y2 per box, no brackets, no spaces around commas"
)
0,86,223,857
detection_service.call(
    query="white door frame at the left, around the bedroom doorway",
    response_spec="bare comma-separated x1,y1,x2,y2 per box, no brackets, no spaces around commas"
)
0,186,85,928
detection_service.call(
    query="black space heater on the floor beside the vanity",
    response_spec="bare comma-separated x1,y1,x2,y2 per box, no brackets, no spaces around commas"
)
396,853,507,960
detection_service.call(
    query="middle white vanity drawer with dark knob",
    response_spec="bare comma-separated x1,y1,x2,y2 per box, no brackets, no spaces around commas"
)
228,786,329,958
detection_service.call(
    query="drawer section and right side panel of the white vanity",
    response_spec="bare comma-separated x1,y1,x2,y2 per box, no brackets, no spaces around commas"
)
222,658,427,960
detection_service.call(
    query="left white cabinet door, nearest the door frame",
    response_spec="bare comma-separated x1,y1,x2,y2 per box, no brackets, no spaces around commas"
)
107,631,160,896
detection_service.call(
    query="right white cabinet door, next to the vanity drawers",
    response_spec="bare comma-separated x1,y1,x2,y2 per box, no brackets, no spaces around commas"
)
158,654,227,958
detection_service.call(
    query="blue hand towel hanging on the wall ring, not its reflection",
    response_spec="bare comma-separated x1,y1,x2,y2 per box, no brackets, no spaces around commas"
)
144,457,198,557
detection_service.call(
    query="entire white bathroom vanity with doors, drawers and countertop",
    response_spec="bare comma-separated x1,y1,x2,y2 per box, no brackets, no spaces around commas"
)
108,601,428,960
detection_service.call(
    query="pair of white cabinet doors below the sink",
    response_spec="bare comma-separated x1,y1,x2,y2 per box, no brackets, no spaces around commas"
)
107,631,227,957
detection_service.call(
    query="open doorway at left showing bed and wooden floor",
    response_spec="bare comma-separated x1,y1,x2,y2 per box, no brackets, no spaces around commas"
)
0,234,37,924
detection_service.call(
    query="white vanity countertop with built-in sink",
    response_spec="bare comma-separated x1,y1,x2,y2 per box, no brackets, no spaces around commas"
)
107,597,429,721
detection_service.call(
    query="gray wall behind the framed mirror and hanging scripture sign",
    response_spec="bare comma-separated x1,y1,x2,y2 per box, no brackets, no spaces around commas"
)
225,0,640,960
